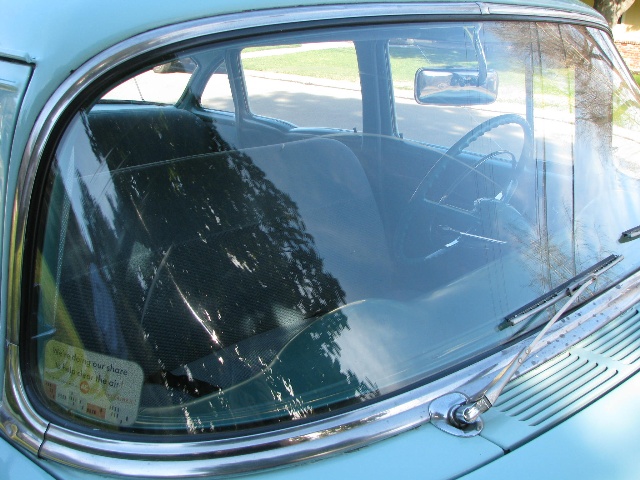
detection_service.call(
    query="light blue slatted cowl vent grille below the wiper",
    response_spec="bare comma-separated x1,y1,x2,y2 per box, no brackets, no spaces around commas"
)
482,309,640,450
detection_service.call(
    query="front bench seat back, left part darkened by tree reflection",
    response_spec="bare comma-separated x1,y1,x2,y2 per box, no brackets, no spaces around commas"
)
129,139,391,374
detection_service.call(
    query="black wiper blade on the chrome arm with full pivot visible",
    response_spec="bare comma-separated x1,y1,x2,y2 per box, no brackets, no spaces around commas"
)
504,255,622,326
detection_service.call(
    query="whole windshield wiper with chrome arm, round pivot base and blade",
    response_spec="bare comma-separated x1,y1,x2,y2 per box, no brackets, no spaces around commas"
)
429,255,622,437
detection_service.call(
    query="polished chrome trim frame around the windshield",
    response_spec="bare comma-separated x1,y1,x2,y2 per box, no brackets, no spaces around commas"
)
0,3,624,477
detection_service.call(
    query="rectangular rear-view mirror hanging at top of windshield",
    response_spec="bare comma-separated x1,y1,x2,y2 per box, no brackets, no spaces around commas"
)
414,68,499,105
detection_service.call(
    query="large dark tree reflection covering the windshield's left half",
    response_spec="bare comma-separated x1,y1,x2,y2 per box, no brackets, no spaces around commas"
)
36,109,376,432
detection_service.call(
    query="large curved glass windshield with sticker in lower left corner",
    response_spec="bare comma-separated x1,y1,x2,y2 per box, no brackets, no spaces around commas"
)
27,22,640,434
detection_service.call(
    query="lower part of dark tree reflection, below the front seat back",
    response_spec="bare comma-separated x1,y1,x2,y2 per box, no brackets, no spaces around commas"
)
188,311,380,433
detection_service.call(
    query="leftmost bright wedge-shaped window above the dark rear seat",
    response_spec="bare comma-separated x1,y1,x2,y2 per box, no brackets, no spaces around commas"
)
102,58,196,105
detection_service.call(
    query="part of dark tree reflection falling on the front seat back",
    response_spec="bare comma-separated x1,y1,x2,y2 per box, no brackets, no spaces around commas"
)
79,114,344,374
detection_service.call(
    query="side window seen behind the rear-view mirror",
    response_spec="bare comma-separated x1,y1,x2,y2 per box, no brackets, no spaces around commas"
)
389,26,527,154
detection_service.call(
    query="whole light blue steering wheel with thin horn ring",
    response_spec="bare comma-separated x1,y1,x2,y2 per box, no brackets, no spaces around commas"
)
393,114,533,264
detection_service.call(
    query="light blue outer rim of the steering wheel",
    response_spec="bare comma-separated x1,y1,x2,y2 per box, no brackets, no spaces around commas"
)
394,113,533,264
